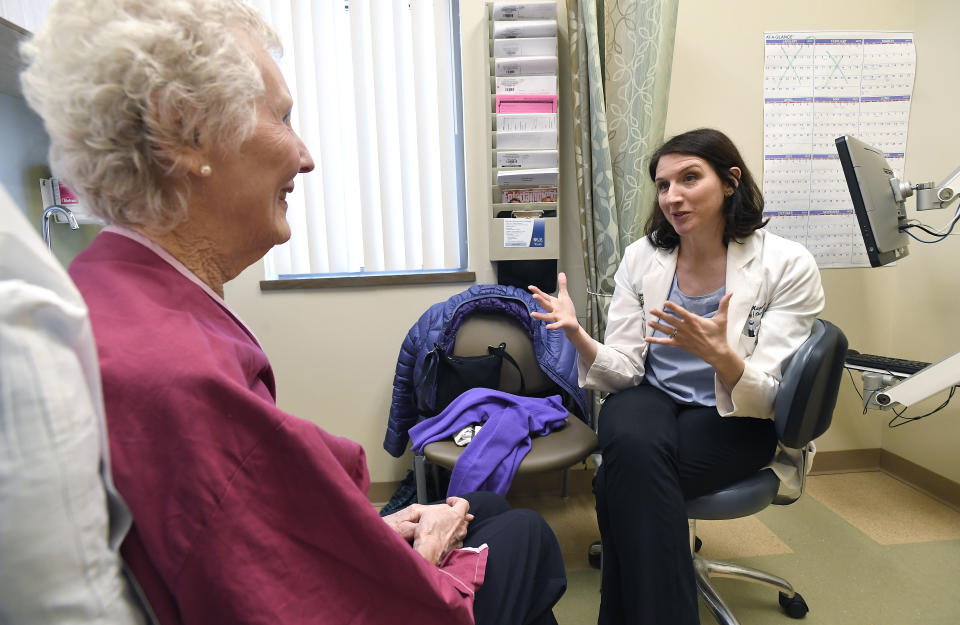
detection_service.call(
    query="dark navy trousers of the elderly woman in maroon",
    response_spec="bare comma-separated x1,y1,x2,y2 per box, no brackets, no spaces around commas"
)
463,492,567,625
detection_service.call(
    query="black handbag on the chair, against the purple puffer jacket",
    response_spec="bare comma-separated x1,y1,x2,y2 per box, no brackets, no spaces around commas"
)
416,343,526,417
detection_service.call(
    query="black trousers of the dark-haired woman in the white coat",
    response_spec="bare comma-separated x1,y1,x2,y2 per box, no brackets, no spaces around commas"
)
594,384,777,625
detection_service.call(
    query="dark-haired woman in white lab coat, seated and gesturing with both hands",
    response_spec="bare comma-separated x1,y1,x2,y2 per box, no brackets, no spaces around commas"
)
531,129,823,625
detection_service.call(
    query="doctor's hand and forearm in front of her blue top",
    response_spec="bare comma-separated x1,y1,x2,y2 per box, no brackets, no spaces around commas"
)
643,293,744,390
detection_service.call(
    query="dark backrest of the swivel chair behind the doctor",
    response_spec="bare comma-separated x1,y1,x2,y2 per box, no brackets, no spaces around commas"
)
774,319,847,449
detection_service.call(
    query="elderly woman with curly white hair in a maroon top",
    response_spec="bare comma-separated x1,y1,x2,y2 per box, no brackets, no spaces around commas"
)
22,0,566,624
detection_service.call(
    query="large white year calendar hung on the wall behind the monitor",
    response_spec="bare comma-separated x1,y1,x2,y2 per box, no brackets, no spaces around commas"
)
763,31,916,267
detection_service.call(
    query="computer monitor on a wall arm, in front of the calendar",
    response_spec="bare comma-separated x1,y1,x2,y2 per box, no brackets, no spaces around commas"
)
836,135,910,267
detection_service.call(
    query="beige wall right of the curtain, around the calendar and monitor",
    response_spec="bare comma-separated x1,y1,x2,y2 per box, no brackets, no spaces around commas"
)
667,0,960,481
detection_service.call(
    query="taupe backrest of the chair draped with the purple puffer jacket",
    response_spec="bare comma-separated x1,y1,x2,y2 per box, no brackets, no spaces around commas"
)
453,313,555,395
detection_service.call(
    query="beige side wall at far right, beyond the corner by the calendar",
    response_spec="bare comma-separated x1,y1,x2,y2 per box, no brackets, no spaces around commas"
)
883,0,960,482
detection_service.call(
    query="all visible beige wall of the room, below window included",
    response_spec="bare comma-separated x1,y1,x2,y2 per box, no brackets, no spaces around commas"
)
227,0,960,481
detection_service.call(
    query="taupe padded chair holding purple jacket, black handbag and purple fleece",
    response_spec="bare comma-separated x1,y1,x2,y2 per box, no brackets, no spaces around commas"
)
413,313,597,503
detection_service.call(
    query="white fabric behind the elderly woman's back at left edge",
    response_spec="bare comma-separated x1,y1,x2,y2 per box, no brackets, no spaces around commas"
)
0,186,145,625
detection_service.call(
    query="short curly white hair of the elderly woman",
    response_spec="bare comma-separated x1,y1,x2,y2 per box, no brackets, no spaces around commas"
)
20,0,281,231
